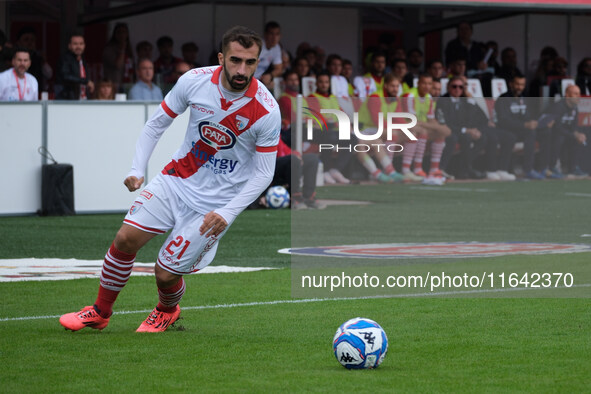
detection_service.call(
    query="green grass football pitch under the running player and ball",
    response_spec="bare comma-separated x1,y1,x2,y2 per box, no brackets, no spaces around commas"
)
0,181,591,393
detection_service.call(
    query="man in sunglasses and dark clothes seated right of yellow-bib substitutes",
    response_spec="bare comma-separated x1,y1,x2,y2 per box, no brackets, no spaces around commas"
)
437,77,515,181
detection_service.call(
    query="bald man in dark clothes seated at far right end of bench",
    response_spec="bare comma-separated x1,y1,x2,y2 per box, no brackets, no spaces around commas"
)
540,85,590,179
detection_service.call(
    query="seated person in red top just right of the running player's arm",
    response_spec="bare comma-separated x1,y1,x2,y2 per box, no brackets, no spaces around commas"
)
273,70,325,209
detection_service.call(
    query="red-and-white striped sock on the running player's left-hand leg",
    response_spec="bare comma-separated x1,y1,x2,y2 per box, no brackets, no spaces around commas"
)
94,245,135,318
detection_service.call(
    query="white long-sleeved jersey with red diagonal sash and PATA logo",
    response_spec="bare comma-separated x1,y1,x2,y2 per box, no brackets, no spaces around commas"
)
130,66,281,222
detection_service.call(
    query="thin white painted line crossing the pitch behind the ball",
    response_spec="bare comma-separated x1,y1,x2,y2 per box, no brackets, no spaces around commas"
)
0,283,591,323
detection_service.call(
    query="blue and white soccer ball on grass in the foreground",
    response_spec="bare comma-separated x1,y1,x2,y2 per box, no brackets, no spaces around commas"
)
332,317,388,369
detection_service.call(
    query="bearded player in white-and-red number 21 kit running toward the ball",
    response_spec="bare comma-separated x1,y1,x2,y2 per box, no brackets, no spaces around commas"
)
60,26,281,332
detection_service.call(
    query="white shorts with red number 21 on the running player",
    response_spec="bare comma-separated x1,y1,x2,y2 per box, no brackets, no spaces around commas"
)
123,175,229,275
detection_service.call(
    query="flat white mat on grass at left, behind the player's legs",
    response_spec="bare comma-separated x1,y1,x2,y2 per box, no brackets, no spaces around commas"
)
0,258,275,282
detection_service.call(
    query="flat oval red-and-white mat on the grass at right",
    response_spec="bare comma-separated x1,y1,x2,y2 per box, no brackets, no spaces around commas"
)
279,242,591,259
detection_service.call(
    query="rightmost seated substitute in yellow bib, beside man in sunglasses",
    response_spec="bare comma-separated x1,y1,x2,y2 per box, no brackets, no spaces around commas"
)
402,73,451,185
